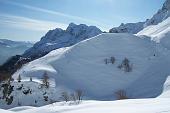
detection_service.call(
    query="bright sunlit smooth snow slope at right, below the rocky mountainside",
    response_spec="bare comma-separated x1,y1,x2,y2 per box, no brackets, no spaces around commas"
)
137,17,170,49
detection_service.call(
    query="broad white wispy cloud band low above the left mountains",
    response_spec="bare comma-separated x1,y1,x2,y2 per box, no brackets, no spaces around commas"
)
0,14,67,31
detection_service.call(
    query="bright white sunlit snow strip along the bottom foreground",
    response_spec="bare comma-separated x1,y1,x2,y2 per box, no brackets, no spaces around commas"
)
0,98,170,113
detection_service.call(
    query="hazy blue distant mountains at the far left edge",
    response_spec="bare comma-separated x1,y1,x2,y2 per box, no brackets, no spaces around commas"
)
0,39,33,65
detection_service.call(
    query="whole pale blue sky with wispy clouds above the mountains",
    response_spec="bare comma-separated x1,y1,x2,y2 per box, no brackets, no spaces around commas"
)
0,0,165,41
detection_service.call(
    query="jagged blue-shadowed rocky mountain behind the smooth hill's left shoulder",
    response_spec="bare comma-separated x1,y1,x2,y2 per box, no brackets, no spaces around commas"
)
23,23,102,59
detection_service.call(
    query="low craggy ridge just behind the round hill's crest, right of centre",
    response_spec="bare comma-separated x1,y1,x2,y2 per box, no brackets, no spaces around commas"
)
109,22,145,34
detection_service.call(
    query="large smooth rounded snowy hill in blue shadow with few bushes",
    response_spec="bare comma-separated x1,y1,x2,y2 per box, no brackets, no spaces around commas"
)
13,33,170,100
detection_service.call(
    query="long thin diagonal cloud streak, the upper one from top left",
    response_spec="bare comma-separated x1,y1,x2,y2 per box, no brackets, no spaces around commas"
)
1,0,101,25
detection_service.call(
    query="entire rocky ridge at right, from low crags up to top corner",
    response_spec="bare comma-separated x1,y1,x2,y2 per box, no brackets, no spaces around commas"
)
109,0,170,34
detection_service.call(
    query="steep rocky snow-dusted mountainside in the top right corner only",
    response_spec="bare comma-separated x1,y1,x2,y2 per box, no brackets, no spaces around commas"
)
144,0,170,27
